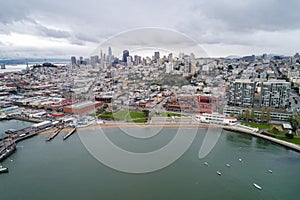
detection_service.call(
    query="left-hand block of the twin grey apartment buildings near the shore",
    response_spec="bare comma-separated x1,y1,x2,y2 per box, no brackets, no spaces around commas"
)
227,79,255,107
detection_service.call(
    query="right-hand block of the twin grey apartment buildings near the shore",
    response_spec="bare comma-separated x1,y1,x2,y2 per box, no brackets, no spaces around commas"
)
261,80,291,109
